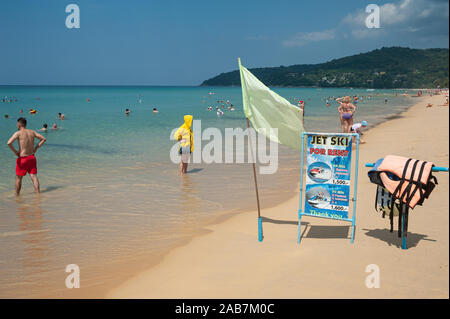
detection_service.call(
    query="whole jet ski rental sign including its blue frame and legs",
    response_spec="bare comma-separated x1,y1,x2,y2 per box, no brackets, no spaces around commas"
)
298,132,359,243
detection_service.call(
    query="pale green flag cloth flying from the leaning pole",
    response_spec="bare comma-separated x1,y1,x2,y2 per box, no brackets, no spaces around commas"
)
238,59,303,149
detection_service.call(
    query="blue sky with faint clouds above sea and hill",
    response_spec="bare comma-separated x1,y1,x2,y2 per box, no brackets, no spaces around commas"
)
0,0,449,85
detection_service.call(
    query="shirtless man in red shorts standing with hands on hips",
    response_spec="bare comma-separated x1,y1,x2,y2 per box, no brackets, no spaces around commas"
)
8,117,46,196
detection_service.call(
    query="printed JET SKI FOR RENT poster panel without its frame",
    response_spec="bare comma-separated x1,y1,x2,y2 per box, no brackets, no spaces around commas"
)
305,135,352,219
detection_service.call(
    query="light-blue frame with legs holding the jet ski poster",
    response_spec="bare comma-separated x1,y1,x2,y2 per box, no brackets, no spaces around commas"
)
297,132,359,244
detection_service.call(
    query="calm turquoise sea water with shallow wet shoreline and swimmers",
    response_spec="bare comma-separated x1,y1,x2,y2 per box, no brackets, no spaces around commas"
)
0,87,414,297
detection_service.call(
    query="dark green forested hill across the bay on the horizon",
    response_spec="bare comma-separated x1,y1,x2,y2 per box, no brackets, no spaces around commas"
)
201,47,449,88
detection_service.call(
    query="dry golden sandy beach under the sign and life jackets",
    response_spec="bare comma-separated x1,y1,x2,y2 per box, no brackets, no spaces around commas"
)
106,95,449,298
